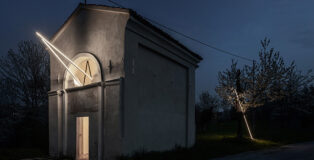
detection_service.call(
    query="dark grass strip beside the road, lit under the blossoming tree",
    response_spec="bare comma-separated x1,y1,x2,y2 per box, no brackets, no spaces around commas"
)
120,121,314,160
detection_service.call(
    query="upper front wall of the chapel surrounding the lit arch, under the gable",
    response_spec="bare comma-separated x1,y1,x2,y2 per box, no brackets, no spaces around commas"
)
50,7,129,91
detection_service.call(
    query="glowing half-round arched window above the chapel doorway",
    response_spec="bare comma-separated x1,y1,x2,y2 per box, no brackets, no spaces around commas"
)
64,53,102,89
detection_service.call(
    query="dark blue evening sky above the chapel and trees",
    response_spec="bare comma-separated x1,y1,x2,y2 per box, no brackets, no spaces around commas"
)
0,0,314,97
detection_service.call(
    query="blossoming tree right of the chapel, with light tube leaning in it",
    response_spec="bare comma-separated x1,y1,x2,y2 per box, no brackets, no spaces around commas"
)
216,38,313,137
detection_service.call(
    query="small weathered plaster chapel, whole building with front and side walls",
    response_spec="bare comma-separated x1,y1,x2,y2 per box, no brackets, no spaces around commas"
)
48,4,202,159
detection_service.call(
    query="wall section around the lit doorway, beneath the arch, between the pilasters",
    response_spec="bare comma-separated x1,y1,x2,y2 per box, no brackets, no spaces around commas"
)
63,87,100,159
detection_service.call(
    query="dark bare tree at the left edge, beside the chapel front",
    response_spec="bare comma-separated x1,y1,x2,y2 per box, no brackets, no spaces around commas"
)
0,41,50,146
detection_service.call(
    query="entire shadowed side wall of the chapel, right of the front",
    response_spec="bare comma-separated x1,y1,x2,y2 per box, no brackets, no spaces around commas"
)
123,19,196,154
